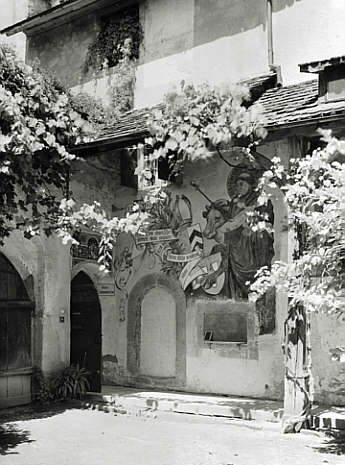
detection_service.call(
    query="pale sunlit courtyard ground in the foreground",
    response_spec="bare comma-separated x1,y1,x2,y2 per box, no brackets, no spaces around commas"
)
0,409,345,465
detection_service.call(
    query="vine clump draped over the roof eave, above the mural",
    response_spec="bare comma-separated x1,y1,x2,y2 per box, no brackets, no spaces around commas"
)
145,82,266,181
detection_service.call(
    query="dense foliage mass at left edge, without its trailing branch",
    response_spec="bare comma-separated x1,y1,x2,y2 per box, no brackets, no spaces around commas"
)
0,46,88,240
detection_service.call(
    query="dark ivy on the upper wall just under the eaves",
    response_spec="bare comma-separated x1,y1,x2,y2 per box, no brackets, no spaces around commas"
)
85,8,143,72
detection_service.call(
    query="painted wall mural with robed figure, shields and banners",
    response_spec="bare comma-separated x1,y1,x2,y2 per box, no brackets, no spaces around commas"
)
114,160,275,330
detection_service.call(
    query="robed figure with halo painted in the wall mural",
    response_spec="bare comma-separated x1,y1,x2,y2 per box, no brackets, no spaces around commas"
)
203,165,274,299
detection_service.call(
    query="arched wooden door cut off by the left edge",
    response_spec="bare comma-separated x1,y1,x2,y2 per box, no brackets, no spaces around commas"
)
0,253,34,407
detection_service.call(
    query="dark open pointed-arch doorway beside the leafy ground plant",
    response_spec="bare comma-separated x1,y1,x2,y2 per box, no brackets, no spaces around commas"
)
71,272,102,392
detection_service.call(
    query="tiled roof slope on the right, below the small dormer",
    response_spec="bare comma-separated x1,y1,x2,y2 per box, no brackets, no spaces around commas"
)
255,80,345,130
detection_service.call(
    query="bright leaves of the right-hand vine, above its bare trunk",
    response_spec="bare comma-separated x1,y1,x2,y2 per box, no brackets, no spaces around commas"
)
252,131,345,316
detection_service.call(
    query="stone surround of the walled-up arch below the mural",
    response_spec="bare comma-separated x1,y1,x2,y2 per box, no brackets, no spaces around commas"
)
127,273,186,387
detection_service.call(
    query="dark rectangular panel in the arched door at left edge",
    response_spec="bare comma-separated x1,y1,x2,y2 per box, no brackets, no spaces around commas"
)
7,308,31,370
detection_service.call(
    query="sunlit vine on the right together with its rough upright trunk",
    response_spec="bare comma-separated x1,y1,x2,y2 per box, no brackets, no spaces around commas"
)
251,131,345,432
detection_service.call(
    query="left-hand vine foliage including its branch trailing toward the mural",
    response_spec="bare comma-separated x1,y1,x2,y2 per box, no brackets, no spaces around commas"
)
0,42,143,260
